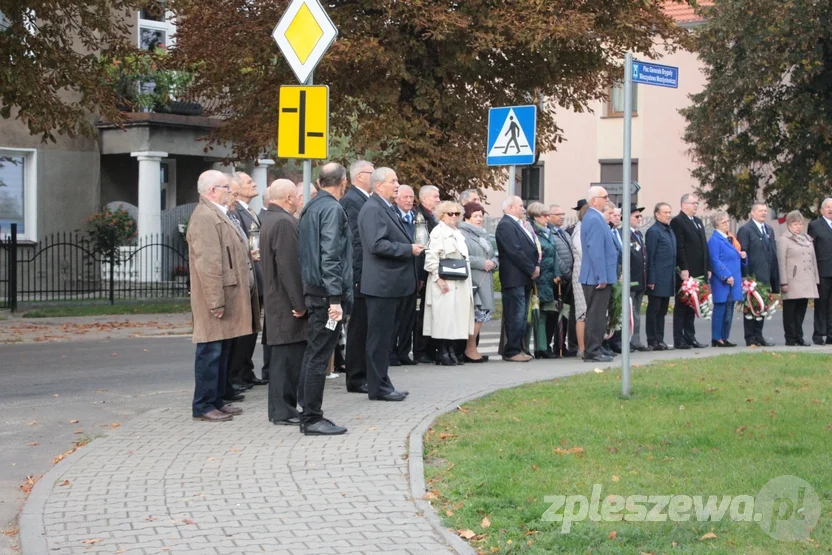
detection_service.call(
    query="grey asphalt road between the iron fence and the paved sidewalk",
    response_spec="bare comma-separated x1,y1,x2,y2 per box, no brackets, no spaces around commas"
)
0,311,812,553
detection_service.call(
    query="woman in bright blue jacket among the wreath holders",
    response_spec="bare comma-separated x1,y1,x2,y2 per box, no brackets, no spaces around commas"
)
708,212,748,347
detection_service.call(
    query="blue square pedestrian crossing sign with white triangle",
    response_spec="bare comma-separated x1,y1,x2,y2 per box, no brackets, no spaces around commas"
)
485,105,537,166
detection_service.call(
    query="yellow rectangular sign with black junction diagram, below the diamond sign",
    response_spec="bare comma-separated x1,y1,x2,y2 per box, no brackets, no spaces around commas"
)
277,85,329,160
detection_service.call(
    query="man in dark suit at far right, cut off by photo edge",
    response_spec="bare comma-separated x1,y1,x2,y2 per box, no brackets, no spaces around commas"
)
809,198,832,345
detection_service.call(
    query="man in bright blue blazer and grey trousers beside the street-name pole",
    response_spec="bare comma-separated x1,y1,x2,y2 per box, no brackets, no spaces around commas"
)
579,185,618,362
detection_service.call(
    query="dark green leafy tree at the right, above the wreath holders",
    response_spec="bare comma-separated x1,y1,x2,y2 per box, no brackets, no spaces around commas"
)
682,0,832,217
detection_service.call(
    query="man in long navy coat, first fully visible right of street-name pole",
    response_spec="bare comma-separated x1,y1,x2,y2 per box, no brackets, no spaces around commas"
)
645,202,676,351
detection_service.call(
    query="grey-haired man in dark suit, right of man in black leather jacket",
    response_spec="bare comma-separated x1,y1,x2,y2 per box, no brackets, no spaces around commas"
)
358,168,425,401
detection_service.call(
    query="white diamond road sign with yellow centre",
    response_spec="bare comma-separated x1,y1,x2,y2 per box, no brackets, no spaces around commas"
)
272,0,338,85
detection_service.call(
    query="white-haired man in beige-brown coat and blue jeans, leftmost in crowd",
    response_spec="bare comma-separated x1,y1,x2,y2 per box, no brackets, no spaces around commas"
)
187,170,260,422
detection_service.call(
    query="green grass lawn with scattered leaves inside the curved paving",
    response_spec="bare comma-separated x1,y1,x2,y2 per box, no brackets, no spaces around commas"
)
425,353,832,554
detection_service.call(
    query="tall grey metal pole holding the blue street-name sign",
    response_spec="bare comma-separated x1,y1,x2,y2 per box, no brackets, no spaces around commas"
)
621,52,641,399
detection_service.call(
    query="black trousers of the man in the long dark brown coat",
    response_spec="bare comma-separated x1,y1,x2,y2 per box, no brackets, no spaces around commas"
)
264,341,306,422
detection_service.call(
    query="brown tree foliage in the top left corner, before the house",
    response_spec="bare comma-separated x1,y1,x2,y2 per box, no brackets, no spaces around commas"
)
0,0,140,141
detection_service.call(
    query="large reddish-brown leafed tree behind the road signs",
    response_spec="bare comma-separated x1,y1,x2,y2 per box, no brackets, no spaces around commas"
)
171,0,686,195
